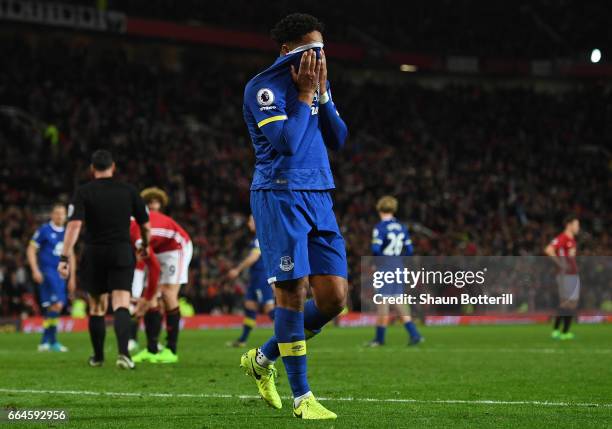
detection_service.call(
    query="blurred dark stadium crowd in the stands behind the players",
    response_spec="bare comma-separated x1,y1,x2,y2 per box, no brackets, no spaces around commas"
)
0,32,612,314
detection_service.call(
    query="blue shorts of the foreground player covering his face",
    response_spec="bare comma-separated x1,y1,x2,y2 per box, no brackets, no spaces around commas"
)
251,190,347,284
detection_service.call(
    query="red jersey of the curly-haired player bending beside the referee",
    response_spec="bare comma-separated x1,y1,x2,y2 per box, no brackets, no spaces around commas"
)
130,211,191,253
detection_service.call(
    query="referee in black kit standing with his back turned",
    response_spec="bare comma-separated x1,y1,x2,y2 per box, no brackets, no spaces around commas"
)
57,150,150,369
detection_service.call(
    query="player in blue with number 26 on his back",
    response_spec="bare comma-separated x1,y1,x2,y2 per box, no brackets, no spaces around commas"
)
367,195,423,347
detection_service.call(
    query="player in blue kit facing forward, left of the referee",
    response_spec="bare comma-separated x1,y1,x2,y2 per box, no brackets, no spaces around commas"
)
26,203,76,352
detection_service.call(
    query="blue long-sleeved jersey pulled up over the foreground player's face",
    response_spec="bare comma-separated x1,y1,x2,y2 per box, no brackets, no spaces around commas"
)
243,43,347,191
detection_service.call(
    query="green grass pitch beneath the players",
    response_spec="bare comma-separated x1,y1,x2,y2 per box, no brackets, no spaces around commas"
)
0,325,612,429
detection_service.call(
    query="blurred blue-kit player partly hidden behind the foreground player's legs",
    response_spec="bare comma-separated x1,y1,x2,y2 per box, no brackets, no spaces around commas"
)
227,215,274,347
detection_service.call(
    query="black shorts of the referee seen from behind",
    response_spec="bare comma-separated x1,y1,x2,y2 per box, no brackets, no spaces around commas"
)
81,244,136,295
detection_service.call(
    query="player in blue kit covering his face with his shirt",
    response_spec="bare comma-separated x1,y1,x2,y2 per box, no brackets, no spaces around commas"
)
240,14,347,419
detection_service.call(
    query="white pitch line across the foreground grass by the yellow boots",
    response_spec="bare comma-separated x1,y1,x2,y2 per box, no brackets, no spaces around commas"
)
0,388,612,408
